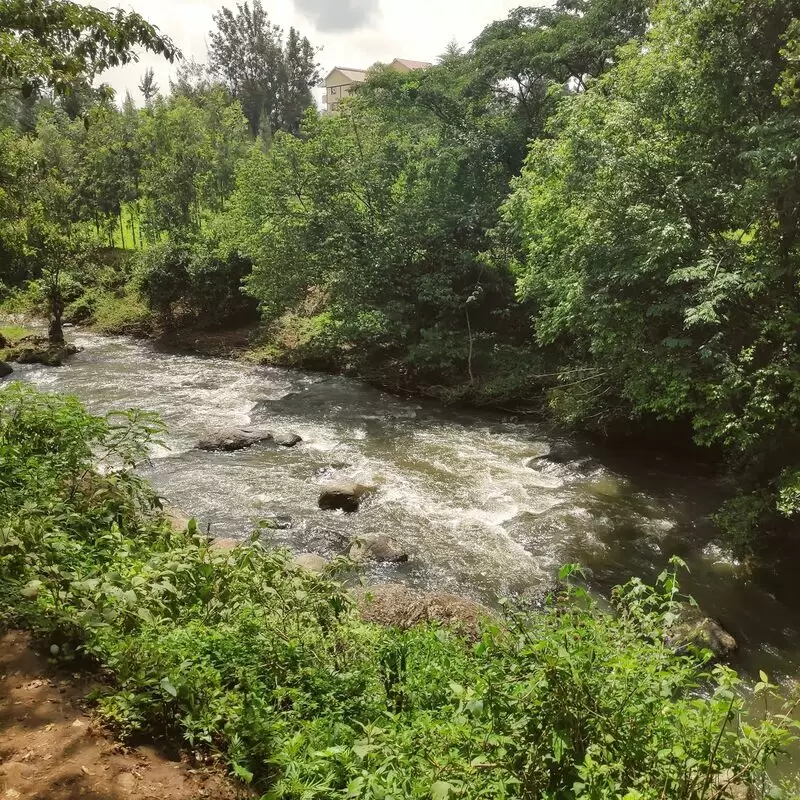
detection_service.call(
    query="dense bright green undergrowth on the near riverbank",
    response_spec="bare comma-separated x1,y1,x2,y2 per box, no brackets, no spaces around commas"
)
0,384,795,800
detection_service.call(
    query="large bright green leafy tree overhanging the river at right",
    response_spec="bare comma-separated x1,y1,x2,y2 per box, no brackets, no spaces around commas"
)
505,0,800,546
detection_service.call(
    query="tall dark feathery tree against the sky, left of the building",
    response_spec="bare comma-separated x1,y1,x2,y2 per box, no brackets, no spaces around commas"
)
209,0,319,137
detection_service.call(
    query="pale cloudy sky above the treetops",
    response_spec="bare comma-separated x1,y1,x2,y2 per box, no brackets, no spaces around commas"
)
81,0,537,104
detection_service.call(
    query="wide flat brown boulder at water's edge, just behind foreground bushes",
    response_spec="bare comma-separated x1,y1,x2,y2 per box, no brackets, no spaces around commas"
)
354,583,494,640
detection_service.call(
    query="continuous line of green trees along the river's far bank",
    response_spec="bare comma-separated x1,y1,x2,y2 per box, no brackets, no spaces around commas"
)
0,0,800,550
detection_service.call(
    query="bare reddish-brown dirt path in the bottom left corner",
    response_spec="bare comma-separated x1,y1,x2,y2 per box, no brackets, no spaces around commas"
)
0,631,244,800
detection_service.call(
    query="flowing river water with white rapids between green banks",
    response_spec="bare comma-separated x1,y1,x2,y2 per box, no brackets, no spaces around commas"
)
10,333,800,678
